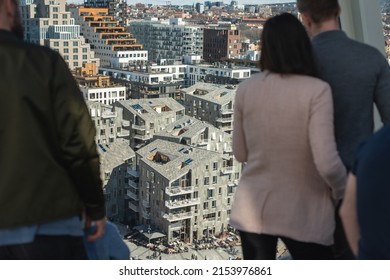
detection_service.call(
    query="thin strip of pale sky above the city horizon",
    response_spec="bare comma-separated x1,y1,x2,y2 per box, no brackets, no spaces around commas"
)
67,0,295,5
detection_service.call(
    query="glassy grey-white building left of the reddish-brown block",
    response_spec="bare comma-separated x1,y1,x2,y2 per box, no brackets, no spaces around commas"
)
128,18,203,62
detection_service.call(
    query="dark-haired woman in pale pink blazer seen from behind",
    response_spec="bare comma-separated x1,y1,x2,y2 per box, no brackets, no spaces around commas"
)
230,14,346,259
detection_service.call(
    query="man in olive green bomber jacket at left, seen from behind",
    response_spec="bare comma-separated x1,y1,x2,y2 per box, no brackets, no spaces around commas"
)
0,0,105,259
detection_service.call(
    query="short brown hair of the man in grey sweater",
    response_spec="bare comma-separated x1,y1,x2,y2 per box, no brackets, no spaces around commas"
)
297,0,340,24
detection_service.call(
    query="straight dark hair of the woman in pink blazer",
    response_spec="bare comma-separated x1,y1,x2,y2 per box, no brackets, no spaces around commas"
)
259,13,318,77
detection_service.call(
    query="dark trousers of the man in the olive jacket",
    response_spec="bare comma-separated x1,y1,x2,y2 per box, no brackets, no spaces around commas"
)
0,235,87,260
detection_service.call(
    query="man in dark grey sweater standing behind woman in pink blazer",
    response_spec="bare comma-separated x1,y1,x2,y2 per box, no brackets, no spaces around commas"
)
297,0,390,259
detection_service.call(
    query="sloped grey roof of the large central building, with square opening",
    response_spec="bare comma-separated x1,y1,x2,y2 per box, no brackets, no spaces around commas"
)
137,139,220,180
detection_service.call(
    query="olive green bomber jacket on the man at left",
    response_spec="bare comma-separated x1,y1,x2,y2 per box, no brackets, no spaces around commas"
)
0,30,105,228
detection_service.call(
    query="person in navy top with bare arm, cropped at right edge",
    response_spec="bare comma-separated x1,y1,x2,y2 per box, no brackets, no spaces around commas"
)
340,125,390,260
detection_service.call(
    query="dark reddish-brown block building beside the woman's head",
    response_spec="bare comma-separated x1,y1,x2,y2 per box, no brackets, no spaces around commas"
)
203,24,241,62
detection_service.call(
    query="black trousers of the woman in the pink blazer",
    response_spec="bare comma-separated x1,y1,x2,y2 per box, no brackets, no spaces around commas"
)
240,231,333,260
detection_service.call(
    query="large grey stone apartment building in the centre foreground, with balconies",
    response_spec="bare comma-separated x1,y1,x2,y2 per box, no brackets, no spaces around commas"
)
133,139,240,243
